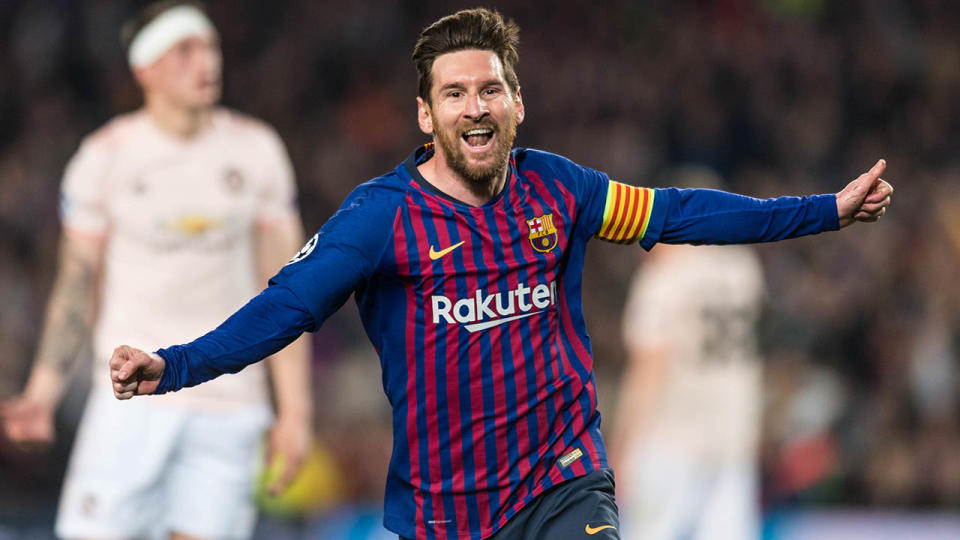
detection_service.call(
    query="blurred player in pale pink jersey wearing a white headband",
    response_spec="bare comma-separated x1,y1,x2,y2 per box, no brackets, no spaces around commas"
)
0,2,311,538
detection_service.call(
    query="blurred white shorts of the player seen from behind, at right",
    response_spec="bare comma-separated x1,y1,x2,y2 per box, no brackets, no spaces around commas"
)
618,451,760,540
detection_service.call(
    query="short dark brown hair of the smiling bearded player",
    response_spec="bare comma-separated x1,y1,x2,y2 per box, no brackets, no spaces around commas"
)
411,8,520,103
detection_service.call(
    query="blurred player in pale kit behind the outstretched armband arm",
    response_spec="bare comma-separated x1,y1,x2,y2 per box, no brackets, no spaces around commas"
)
612,167,764,540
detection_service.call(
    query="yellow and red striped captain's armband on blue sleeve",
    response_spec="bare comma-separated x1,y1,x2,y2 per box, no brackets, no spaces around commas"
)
597,180,654,244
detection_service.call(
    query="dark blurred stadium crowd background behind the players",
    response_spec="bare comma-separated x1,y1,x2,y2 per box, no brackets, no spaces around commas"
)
0,0,960,539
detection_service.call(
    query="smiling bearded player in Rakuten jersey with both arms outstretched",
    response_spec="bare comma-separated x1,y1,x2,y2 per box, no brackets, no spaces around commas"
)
105,9,893,540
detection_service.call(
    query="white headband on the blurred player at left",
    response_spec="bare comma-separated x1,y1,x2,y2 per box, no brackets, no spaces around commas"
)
127,6,215,68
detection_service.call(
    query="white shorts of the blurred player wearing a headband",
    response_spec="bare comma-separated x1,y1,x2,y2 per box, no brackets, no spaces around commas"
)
56,386,271,539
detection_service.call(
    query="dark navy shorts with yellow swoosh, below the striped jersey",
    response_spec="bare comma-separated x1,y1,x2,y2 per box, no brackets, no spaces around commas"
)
401,469,620,540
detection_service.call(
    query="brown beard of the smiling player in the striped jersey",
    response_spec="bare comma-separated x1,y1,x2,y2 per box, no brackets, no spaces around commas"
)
433,109,517,196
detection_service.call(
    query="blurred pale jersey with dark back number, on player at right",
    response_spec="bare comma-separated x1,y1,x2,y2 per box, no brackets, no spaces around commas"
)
624,246,764,460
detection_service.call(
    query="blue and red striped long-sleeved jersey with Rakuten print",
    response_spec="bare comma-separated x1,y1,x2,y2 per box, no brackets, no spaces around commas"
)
157,141,838,539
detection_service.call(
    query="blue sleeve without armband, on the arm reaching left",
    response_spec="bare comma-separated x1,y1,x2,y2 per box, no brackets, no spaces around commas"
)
155,179,403,393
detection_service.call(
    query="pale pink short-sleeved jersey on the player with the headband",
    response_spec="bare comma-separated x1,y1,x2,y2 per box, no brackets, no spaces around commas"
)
61,109,296,408
